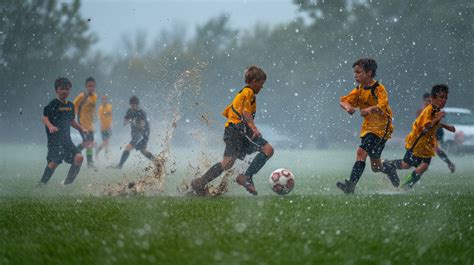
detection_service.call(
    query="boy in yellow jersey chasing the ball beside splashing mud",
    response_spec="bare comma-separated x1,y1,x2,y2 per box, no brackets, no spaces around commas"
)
191,66,273,195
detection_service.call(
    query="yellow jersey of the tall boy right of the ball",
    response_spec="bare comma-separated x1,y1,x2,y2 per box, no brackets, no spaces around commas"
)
341,80,393,139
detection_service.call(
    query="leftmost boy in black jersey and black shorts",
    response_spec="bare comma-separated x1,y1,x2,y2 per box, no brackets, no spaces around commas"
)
40,77,87,185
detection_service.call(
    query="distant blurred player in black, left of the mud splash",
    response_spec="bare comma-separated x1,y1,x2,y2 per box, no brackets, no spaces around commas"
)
114,96,155,169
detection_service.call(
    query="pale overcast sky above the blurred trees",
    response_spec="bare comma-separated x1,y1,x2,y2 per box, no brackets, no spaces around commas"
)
81,0,297,52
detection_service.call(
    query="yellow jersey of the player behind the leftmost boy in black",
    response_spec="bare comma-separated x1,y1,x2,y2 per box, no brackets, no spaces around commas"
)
74,92,97,132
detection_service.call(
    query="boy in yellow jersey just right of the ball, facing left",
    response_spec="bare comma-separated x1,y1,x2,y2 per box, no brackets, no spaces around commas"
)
336,58,400,193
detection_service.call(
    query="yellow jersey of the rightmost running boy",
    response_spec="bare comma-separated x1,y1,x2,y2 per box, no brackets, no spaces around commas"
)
405,105,441,158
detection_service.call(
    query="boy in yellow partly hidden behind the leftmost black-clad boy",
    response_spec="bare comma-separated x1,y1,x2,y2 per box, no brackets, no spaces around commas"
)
74,77,97,170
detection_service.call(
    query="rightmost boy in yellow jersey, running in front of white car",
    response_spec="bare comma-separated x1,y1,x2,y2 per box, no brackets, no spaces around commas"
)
387,84,456,189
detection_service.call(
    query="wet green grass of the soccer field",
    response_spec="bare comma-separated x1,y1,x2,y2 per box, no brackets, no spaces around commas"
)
0,145,474,265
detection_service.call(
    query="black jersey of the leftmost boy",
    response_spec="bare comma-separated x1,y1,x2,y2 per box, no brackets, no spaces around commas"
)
43,99,75,147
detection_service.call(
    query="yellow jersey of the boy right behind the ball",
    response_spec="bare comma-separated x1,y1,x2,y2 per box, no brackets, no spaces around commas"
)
222,87,257,127
